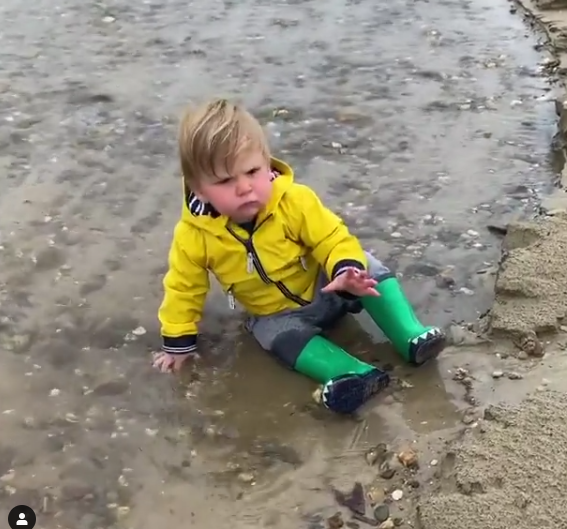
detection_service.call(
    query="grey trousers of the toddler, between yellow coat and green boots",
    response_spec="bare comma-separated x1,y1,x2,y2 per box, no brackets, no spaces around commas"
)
245,253,391,351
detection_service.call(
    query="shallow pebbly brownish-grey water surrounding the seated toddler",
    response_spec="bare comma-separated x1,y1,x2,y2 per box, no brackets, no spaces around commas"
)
0,0,554,529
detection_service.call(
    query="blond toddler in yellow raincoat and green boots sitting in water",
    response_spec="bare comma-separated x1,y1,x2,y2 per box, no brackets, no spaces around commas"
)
154,99,445,414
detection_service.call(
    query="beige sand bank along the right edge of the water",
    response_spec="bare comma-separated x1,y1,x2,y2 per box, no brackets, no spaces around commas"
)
417,0,567,529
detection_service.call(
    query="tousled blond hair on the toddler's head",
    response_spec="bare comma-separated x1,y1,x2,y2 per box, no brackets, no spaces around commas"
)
179,99,270,187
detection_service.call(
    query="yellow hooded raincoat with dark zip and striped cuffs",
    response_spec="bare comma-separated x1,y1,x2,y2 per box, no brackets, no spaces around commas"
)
159,159,367,353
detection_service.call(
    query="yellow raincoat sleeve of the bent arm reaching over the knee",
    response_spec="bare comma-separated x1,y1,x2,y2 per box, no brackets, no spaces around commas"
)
287,183,368,280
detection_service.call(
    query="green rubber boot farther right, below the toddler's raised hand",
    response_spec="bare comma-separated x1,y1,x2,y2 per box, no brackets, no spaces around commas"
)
361,277,445,365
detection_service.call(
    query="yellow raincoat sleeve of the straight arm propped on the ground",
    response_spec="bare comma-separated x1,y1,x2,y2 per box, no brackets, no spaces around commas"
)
158,221,209,354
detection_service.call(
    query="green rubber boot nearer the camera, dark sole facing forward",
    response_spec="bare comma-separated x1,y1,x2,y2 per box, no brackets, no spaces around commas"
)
294,336,390,414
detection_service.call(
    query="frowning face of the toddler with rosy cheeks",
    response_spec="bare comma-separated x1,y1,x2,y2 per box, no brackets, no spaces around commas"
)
195,150,272,222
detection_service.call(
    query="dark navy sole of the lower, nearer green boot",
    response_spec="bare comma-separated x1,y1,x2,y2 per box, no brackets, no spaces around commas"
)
323,369,390,415
